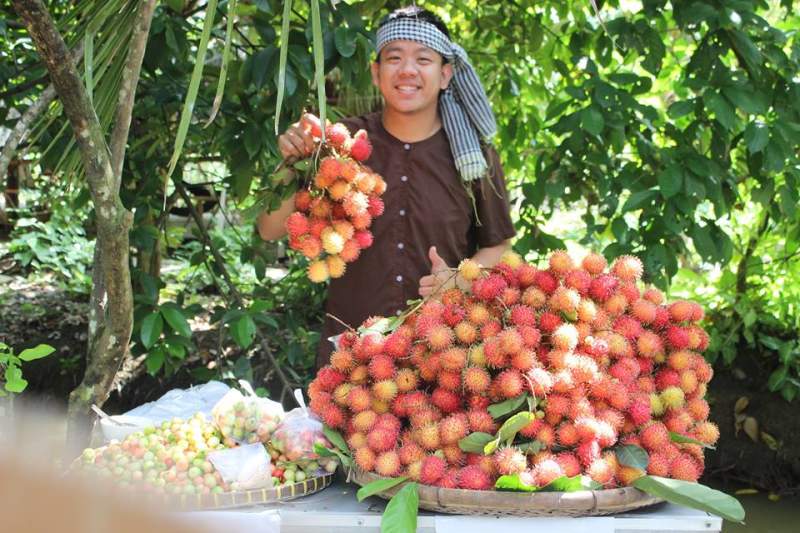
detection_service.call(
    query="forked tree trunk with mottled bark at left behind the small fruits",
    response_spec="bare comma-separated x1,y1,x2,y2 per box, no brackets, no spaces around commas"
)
13,0,156,450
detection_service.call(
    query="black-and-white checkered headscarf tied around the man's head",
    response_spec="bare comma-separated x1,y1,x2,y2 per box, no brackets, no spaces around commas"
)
375,18,497,181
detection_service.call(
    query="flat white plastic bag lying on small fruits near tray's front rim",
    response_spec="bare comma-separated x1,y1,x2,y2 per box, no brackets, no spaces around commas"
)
208,442,272,491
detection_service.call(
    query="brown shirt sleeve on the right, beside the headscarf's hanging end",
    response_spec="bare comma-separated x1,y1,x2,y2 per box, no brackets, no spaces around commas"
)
473,146,516,248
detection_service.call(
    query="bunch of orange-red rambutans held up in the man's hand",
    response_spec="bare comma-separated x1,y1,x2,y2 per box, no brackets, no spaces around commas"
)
286,116,386,283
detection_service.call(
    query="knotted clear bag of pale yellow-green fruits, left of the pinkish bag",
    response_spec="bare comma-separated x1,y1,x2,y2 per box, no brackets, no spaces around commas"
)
211,380,285,446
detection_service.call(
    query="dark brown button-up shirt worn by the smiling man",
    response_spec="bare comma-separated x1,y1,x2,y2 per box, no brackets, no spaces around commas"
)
317,112,514,367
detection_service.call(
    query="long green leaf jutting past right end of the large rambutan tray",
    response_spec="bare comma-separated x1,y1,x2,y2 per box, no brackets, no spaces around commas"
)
633,476,744,523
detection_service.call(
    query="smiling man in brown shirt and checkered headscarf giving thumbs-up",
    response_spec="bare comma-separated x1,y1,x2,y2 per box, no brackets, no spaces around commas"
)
259,7,514,366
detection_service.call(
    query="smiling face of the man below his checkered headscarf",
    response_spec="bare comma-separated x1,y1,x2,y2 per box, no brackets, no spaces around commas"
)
372,41,453,114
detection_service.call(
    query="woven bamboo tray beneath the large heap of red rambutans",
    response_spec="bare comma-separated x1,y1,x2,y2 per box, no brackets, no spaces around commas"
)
350,469,664,517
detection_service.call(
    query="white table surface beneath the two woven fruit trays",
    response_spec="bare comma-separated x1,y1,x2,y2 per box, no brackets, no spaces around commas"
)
193,481,722,533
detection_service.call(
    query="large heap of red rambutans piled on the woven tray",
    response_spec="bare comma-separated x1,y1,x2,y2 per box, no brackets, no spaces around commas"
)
309,251,719,490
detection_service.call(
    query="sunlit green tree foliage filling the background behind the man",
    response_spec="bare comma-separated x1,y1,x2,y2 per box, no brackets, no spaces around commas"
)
0,0,800,401
